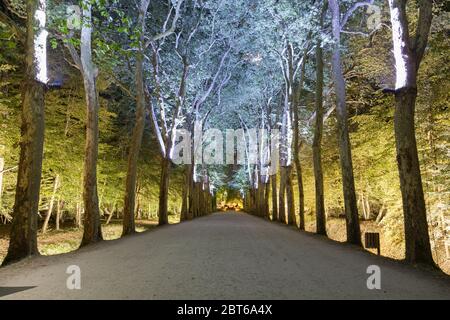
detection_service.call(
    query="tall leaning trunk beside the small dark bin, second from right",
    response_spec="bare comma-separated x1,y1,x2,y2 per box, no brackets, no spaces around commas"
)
328,0,361,246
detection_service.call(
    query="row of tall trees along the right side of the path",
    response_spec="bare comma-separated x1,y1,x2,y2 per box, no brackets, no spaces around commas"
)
236,0,440,264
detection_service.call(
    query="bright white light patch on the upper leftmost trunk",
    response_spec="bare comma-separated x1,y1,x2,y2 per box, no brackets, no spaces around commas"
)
34,0,48,84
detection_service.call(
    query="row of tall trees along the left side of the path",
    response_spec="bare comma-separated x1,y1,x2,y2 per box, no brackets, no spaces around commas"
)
3,0,231,264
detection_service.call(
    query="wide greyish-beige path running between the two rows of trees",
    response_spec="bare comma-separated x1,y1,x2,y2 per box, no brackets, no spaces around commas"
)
0,213,450,299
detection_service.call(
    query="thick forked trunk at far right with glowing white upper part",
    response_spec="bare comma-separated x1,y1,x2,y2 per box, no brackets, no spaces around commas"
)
389,0,434,265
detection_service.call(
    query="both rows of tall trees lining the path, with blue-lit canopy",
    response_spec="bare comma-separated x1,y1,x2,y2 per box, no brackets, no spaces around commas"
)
0,0,444,270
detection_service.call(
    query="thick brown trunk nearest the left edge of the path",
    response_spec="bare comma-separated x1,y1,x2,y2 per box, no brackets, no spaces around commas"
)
3,0,44,265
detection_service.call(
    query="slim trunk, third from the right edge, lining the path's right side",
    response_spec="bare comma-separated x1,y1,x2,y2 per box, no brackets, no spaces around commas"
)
312,33,327,235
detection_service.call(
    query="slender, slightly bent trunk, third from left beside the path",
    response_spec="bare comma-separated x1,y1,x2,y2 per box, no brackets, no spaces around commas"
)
122,0,150,236
